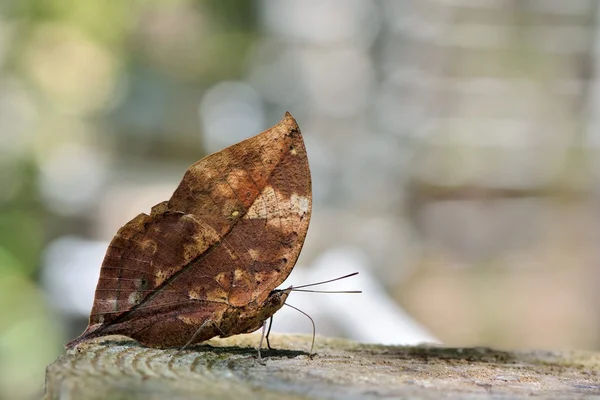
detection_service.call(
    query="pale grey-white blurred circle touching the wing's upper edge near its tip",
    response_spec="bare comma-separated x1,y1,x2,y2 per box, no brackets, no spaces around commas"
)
199,81,265,152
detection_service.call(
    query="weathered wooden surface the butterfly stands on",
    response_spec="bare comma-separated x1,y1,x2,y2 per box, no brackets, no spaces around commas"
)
45,335,600,400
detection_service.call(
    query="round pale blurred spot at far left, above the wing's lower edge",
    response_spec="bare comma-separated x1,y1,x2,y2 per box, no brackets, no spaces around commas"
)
39,143,107,215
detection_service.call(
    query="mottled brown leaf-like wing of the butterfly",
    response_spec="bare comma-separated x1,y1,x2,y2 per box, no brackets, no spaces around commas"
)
67,113,312,347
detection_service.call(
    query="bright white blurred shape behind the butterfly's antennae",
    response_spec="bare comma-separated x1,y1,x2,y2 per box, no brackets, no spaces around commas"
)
274,247,439,345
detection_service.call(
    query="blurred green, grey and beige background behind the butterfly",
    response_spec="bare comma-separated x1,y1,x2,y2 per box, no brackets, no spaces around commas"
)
0,0,600,398
